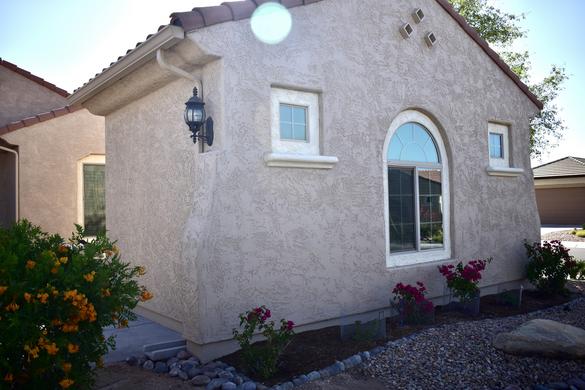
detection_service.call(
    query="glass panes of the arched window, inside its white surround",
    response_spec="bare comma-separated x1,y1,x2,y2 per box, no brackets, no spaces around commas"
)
387,122,444,253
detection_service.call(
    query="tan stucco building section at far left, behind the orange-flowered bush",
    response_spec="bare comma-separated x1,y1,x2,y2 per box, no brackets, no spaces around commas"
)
0,60,105,237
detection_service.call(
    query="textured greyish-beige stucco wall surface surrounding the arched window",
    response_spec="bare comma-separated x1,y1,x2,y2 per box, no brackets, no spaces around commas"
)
88,0,539,356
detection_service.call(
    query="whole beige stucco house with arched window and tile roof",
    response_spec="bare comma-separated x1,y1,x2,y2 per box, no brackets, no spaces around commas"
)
69,0,542,359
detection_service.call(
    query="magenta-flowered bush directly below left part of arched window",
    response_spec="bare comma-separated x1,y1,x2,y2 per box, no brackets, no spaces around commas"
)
392,282,434,324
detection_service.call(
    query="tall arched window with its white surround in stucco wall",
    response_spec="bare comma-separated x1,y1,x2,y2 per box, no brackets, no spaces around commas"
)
384,111,450,266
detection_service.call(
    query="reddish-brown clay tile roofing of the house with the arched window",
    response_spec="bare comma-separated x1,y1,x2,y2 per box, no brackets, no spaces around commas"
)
69,0,543,110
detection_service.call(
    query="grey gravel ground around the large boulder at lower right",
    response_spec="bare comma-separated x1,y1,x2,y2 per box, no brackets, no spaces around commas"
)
363,298,585,389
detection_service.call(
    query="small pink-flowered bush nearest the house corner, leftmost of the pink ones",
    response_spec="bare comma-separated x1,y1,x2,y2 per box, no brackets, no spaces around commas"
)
233,306,295,379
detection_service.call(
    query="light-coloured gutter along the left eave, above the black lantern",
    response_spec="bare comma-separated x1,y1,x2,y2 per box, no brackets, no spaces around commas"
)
67,25,185,105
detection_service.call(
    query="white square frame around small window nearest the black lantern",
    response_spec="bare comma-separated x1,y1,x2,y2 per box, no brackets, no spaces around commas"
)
271,88,319,156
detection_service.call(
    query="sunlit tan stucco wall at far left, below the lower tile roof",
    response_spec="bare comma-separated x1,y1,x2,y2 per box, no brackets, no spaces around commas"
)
2,110,105,237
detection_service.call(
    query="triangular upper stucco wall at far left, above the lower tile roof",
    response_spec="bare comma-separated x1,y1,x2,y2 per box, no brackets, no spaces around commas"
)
0,66,67,127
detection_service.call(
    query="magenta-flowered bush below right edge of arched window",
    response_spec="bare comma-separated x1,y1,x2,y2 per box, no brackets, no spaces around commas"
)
439,258,492,301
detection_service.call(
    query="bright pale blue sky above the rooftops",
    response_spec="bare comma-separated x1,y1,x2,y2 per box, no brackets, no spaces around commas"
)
0,0,585,164
